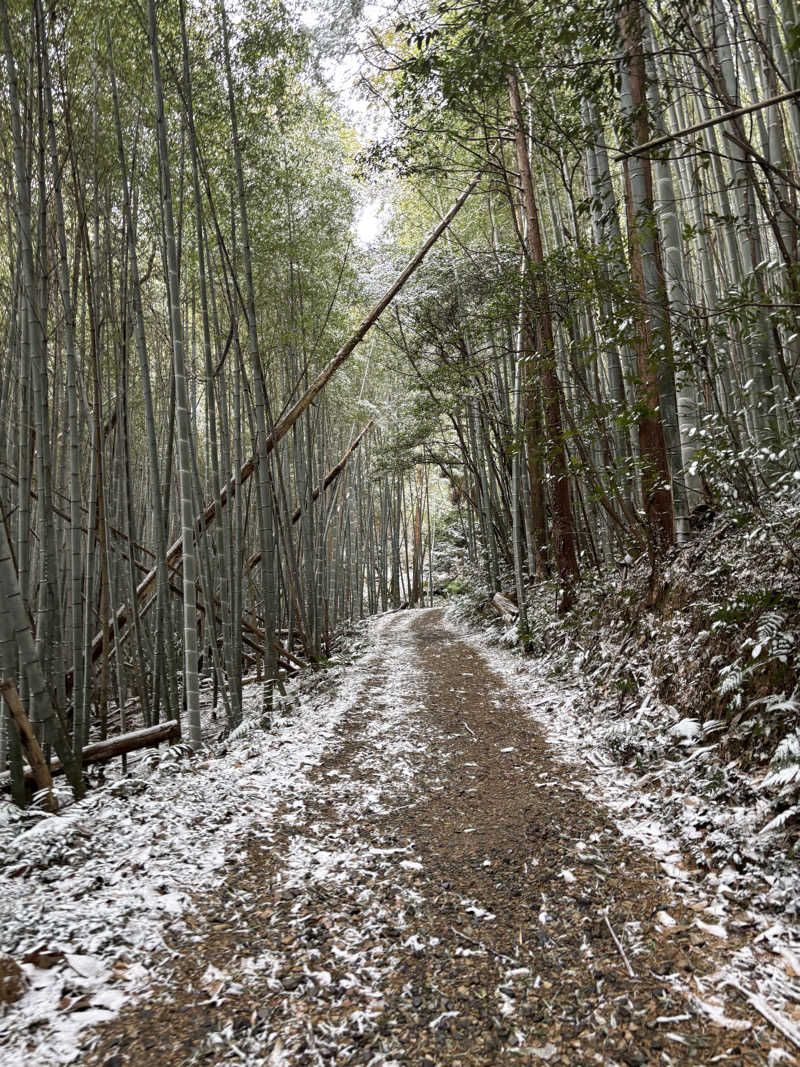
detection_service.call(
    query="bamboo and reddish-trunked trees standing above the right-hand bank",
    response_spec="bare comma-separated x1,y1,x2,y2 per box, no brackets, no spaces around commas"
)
365,0,800,633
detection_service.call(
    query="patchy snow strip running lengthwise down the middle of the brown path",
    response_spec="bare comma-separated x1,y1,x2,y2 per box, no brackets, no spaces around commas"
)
178,614,447,1067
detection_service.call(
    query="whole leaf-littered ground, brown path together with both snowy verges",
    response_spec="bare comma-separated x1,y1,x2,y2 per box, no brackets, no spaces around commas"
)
0,611,795,1067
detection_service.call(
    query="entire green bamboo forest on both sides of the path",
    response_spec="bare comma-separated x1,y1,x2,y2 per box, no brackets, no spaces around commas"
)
0,0,800,802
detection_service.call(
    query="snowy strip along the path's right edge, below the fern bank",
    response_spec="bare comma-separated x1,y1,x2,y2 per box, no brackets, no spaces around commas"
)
448,611,800,1062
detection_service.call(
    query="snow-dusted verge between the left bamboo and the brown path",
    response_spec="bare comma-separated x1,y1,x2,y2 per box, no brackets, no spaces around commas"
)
0,615,412,1067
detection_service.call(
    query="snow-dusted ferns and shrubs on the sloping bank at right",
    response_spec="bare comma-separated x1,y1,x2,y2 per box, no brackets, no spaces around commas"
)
445,487,800,847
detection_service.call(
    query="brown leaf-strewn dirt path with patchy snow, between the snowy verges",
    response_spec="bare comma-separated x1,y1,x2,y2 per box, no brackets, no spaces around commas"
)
79,610,793,1067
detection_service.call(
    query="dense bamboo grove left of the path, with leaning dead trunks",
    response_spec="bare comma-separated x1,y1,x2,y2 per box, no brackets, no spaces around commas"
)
0,0,445,803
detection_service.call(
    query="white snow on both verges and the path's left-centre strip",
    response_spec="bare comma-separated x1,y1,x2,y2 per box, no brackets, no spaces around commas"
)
0,612,800,1067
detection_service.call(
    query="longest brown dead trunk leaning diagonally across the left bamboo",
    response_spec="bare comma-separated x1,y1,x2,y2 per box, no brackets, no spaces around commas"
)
84,178,483,659
